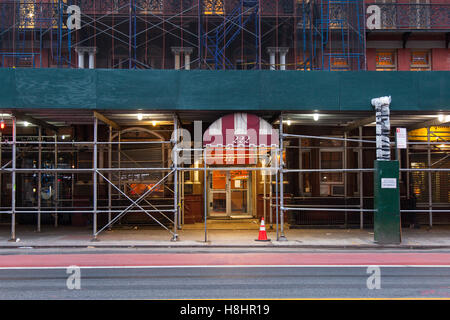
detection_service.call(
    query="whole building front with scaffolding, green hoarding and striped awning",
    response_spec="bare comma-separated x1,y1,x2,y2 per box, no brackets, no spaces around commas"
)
0,0,450,238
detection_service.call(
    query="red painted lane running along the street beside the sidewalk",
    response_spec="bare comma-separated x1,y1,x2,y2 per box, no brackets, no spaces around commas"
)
0,253,450,268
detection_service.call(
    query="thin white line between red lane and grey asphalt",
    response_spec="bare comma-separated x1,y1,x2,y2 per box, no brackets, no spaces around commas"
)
0,264,450,271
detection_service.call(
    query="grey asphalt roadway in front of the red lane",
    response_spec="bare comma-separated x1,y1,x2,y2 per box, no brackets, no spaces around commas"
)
0,266,450,300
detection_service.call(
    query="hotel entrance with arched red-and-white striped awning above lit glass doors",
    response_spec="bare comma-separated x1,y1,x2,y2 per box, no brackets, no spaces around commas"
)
203,113,279,219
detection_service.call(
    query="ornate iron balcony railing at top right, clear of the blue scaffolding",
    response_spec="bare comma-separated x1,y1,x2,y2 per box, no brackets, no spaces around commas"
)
366,2,450,30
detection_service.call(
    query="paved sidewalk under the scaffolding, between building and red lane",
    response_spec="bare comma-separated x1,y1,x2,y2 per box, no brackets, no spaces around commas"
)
0,224,450,249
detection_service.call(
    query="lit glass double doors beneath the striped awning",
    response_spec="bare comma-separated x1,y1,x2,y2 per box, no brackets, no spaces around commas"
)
208,170,252,218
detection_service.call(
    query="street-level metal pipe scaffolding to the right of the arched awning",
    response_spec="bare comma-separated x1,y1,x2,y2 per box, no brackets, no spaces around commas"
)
280,114,450,229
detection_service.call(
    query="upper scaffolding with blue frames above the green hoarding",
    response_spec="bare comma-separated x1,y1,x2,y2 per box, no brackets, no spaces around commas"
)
0,0,365,70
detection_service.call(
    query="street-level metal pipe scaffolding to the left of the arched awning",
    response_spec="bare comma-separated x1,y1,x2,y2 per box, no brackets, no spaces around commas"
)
0,112,181,241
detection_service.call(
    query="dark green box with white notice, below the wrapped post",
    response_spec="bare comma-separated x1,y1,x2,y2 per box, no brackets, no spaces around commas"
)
374,160,402,244
